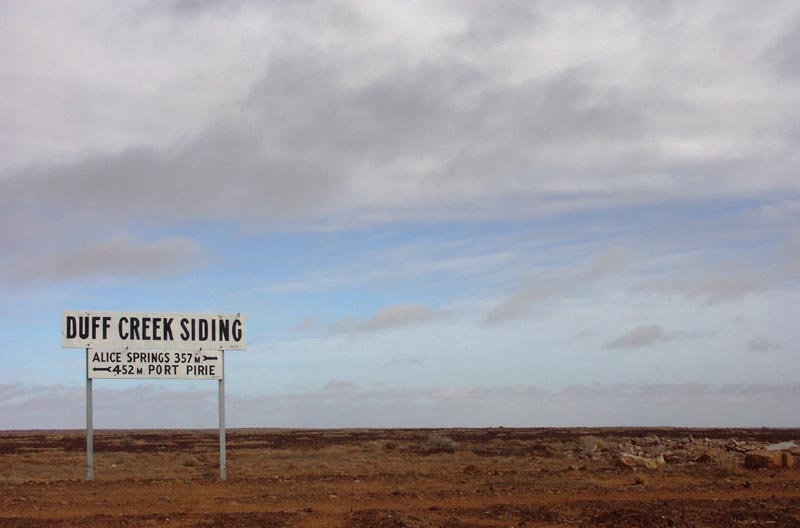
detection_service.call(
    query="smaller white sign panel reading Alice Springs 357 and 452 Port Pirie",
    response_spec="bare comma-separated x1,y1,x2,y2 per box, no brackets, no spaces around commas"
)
86,348,223,380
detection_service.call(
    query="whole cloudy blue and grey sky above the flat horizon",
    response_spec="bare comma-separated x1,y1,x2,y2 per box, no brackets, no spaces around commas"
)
0,0,800,429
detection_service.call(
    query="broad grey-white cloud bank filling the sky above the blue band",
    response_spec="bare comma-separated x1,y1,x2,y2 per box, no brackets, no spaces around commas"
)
0,2,800,262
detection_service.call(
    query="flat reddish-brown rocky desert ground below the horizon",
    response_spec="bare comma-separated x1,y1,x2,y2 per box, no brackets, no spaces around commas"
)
0,428,800,528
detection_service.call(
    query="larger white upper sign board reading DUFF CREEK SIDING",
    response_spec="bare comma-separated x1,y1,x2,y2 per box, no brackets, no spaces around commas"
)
61,311,247,352
